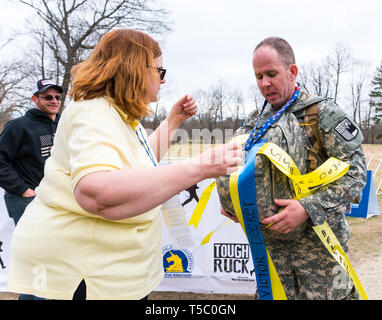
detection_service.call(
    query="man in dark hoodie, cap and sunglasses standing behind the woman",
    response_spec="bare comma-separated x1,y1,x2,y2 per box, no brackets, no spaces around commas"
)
0,79,62,224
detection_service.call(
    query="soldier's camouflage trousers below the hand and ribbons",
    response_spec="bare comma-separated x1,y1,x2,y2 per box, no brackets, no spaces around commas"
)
255,228,359,300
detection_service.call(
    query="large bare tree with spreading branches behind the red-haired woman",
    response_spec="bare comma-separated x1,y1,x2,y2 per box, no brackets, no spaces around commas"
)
19,0,170,106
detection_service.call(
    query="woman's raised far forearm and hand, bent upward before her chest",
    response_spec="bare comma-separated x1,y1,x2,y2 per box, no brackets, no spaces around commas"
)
149,95,197,161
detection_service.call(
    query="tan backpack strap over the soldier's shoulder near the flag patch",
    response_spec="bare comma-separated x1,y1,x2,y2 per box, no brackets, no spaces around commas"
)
304,96,328,171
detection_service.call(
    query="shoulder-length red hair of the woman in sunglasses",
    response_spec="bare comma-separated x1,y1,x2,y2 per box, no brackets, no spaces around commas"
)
69,29,162,120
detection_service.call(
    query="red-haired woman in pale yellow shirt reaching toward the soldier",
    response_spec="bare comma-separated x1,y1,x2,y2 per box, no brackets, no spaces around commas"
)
8,29,243,299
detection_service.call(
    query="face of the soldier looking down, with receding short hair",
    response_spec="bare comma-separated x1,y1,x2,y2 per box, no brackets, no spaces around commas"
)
252,46,297,109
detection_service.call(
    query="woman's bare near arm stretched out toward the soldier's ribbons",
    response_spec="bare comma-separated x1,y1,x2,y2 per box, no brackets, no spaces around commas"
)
74,143,243,220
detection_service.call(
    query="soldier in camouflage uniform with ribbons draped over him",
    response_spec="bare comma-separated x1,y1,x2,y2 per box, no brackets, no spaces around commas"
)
217,38,366,300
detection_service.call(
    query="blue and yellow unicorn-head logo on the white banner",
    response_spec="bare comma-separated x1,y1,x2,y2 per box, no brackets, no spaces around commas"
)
162,245,194,278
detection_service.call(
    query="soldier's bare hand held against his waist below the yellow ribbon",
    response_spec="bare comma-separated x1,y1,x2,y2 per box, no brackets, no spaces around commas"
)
261,199,309,234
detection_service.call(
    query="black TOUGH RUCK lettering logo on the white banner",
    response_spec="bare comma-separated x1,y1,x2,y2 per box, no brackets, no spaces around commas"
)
214,243,254,276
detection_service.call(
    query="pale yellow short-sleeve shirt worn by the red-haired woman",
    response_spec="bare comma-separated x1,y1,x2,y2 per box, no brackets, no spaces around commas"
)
8,98,163,299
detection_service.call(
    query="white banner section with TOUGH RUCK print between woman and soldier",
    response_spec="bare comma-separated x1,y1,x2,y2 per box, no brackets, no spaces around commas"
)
155,179,256,294
